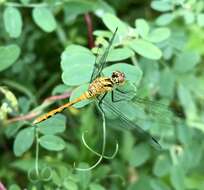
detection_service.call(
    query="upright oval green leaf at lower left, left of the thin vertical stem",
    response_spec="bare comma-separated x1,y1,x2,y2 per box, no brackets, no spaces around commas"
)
13,127,35,156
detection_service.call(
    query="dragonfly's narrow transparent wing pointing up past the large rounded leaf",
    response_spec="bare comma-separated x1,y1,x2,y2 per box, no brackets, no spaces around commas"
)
90,28,118,82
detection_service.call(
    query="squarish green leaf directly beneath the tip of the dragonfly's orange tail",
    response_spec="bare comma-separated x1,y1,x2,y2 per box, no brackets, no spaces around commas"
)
37,114,65,135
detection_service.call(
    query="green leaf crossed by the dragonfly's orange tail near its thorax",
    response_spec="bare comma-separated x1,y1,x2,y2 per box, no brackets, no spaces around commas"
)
70,84,93,108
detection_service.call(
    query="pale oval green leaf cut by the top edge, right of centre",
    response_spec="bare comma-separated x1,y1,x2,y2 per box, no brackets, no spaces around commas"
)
151,0,174,12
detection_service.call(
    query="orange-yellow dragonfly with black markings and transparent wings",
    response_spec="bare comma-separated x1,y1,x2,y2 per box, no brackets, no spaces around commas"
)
33,28,164,149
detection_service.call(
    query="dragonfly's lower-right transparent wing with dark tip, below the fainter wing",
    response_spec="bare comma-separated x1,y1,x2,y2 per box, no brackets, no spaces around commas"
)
99,99,161,149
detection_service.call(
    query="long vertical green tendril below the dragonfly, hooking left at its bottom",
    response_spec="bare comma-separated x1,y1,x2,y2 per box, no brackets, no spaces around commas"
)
74,108,106,171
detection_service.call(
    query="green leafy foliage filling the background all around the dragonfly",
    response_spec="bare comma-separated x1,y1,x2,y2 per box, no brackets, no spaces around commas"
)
0,0,204,190
